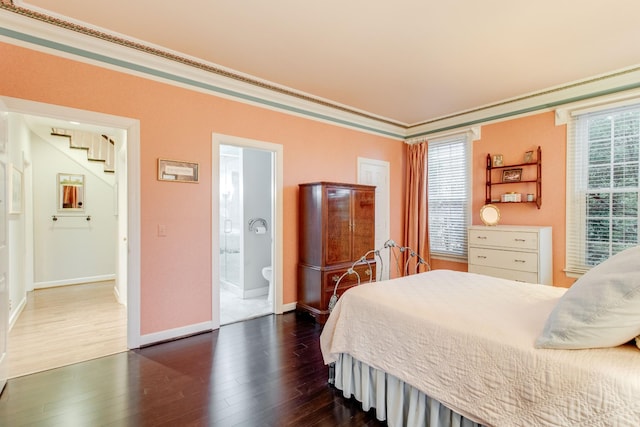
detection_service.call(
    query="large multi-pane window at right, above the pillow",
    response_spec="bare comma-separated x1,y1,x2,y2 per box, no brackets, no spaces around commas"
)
567,104,640,274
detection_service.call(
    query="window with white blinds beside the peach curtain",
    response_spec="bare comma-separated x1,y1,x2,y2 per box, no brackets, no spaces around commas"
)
427,134,470,258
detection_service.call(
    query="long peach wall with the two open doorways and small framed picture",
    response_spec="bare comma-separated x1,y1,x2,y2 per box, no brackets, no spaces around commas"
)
0,43,404,335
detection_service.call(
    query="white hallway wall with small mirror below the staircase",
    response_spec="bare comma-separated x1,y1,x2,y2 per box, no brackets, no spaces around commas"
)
30,133,118,288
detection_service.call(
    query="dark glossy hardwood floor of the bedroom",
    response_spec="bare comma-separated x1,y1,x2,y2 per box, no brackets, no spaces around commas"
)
0,313,385,427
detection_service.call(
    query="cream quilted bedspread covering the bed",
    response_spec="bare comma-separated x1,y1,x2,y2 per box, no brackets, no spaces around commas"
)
320,270,640,426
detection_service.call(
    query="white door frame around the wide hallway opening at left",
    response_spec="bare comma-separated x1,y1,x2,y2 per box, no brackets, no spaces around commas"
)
0,96,141,349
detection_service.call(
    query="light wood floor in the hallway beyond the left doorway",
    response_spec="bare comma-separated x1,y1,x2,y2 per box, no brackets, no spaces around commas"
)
8,281,127,378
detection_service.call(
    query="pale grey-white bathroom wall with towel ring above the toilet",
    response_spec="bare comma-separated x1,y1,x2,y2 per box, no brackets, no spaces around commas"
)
242,148,273,295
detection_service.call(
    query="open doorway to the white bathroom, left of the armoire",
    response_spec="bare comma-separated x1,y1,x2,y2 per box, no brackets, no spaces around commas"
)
212,134,282,327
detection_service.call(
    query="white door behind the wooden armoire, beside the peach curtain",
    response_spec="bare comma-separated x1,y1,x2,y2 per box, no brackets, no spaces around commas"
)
358,157,391,280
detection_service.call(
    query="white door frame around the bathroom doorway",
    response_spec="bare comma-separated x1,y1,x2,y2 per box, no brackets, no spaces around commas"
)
211,133,284,329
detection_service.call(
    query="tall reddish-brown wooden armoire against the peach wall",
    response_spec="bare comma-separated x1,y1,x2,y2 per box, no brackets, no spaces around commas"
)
296,182,376,323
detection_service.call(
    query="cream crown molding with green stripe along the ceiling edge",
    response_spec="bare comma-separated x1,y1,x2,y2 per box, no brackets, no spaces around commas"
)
0,4,640,144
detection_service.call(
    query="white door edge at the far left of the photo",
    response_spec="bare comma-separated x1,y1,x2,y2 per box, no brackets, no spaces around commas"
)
0,101,9,393
